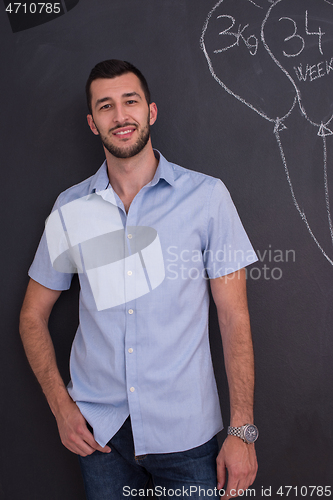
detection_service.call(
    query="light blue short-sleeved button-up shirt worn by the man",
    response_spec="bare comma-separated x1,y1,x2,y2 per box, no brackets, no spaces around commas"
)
29,151,257,455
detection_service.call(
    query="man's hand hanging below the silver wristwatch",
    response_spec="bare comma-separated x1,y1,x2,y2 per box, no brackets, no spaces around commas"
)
216,436,258,498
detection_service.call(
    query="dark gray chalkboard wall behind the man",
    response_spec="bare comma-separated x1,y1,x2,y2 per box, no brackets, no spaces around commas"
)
0,0,333,500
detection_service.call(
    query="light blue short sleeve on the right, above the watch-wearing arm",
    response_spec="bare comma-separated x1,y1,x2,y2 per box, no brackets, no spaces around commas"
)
204,179,258,279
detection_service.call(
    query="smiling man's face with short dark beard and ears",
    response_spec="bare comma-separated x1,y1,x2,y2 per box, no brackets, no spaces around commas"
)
87,73,157,158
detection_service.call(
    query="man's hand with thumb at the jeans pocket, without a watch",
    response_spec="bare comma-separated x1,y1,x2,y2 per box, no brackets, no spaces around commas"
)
56,401,111,457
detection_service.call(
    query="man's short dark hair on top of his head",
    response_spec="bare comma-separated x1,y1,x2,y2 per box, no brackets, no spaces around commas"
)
86,59,150,114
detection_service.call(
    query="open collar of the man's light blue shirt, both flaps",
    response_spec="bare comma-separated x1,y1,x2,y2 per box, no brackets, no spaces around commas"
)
89,149,175,193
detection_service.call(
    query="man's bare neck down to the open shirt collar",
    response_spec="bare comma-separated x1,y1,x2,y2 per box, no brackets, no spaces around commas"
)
105,139,158,212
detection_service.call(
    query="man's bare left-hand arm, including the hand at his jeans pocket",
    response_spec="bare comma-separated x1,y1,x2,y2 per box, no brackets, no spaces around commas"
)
20,280,110,456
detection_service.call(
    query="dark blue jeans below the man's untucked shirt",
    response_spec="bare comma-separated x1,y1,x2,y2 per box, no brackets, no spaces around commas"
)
79,418,219,500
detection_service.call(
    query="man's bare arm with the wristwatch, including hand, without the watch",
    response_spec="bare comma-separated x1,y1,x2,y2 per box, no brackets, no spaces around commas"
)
210,269,258,497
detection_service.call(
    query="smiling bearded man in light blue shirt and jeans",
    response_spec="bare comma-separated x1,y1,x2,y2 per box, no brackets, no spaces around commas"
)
20,60,257,500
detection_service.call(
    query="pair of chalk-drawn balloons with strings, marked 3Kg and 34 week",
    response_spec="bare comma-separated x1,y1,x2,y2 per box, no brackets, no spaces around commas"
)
200,0,333,265
